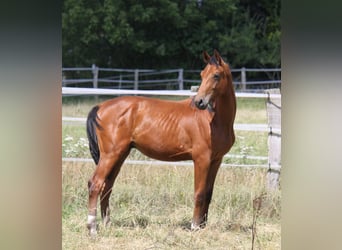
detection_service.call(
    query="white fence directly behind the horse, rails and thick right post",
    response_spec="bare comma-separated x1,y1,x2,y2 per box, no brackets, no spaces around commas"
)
62,87,281,189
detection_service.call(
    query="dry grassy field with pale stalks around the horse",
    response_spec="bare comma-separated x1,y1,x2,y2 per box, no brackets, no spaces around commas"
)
62,95,281,250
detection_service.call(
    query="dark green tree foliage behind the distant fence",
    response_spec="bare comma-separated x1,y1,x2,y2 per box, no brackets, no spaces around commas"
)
62,0,281,69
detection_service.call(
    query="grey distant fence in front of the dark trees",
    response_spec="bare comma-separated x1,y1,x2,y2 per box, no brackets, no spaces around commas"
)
62,64,281,92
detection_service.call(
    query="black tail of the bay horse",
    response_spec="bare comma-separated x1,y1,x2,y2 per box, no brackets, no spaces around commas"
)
87,106,102,165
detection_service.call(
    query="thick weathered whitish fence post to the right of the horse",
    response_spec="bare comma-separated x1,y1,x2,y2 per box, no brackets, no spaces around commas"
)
265,89,281,190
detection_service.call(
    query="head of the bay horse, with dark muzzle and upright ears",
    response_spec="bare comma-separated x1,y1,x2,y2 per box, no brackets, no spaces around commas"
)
194,50,231,110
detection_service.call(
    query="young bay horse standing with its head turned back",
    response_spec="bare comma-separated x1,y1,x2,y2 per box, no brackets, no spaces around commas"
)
87,50,236,235
